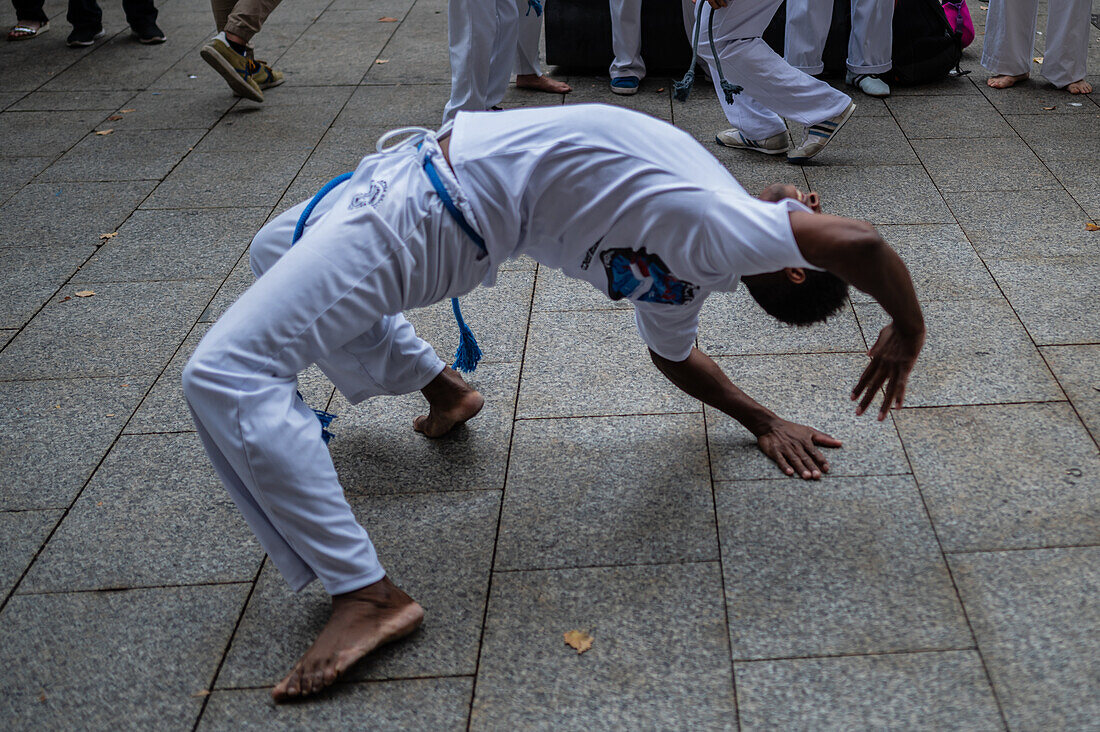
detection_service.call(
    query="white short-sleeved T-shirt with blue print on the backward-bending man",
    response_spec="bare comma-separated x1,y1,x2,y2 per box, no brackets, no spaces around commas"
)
450,105,811,361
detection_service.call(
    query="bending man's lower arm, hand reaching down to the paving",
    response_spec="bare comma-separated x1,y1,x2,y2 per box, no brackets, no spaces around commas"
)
649,348,840,480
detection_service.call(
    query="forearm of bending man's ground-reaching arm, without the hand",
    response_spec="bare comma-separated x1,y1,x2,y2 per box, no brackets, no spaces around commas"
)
649,348,779,437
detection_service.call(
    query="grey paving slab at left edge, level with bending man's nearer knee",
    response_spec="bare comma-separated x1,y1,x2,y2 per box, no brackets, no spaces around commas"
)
0,376,147,511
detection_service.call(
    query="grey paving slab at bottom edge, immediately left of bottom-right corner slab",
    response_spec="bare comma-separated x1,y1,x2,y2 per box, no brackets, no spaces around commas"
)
735,651,1004,732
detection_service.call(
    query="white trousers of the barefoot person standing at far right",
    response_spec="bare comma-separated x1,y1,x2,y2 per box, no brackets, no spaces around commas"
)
981,0,1092,87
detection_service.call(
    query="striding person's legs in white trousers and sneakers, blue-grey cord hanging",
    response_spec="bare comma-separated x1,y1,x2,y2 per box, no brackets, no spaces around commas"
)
699,0,856,163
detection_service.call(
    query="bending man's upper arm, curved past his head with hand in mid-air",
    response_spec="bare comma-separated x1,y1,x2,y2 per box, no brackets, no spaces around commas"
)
791,211,924,420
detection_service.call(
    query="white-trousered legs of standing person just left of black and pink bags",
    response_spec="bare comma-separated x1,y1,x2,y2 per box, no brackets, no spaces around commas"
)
783,0,894,97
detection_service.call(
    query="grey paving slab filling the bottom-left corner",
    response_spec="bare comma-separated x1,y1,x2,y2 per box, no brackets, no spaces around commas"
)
0,584,249,730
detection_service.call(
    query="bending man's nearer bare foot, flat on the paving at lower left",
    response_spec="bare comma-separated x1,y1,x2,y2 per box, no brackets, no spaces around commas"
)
272,577,424,701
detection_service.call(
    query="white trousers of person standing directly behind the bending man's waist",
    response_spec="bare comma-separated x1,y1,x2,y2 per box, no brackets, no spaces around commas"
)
443,0,519,123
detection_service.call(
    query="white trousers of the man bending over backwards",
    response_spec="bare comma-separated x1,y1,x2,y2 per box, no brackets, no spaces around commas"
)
184,134,488,594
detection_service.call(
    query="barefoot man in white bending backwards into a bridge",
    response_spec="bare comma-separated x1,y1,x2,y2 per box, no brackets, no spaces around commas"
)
184,105,924,700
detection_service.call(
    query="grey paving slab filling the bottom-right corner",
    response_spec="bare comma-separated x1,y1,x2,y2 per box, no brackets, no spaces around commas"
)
950,546,1100,730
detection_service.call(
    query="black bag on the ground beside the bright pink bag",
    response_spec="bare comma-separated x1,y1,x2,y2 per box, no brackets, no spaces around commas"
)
887,0,963,86
